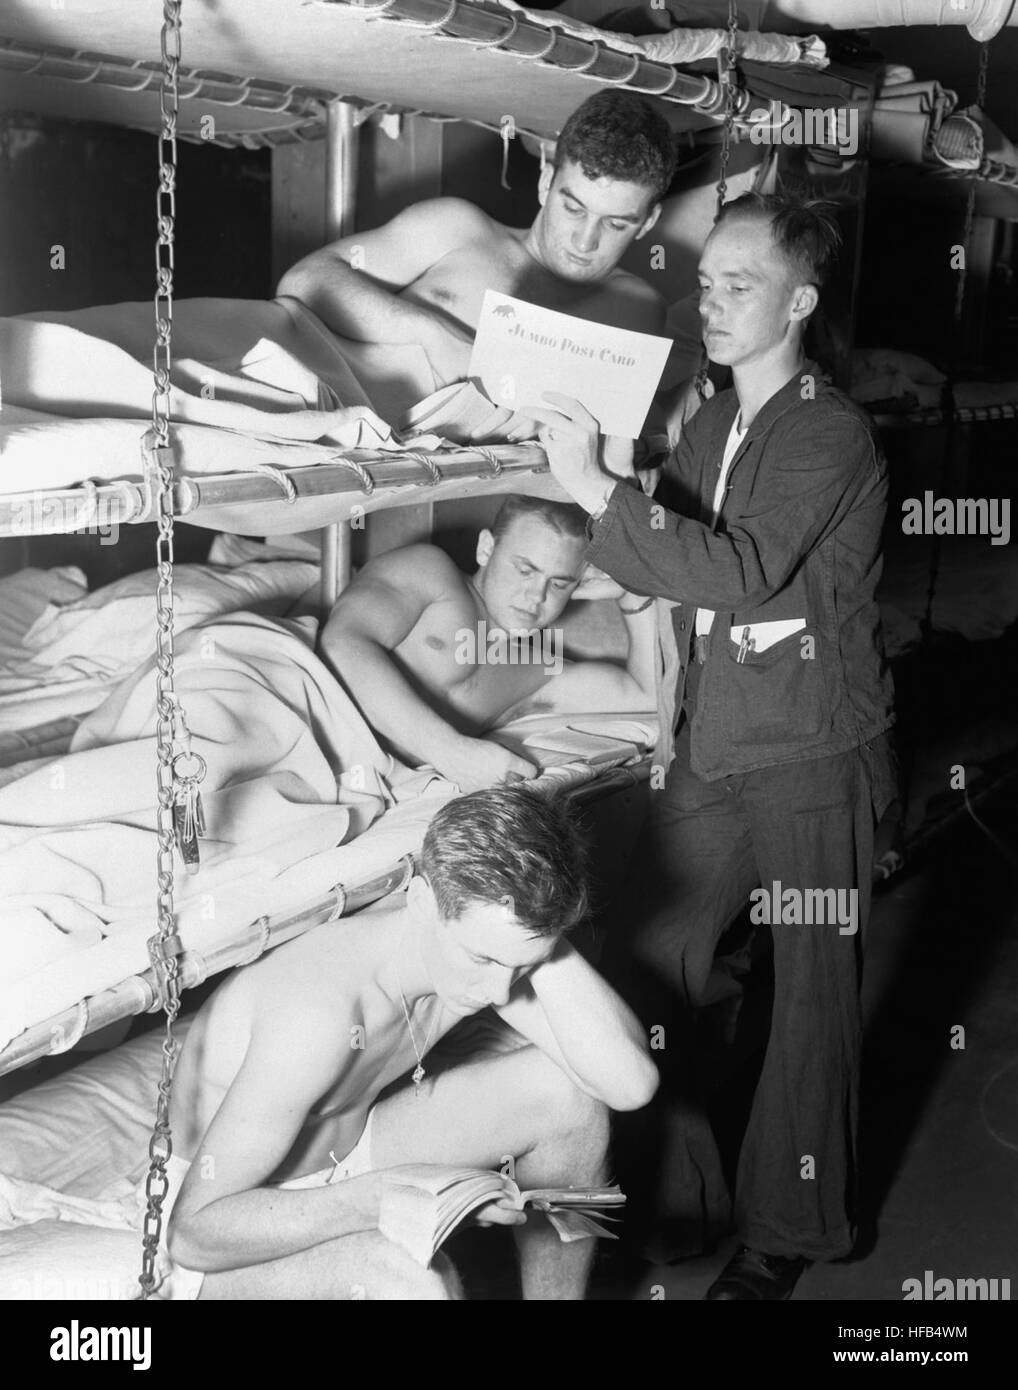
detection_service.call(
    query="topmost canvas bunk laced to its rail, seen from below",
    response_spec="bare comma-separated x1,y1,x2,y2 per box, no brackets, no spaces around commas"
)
0,0,826,140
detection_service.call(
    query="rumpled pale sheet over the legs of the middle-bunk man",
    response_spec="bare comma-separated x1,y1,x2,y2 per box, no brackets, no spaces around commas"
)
0,613,453,1045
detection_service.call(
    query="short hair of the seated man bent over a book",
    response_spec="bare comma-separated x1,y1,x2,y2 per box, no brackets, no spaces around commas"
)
420,784,590,937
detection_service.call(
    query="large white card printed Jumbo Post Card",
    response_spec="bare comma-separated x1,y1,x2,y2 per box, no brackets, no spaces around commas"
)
469,289,672,439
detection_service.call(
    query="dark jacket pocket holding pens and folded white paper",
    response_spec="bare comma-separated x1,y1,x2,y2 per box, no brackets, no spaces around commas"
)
718,619,829,744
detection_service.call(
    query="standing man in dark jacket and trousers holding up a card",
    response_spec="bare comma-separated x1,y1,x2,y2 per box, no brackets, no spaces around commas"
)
528,195,894,1300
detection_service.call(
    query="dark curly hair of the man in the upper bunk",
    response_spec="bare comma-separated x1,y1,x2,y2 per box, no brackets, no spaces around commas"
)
555,92,677,202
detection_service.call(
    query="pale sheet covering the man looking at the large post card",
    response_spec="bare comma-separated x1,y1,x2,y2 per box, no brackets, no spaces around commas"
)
0,297,450,497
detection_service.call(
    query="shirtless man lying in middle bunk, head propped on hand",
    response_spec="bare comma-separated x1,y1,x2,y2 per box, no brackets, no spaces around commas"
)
320,496,656,792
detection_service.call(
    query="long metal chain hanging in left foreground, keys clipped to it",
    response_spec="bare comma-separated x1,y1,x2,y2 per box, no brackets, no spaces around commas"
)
138,0,182,1298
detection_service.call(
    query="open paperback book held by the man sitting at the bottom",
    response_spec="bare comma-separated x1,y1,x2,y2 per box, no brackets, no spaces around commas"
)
378,1163,626,1265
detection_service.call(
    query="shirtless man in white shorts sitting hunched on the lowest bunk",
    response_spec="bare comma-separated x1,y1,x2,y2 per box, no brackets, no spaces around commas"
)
157,787,658,1300
